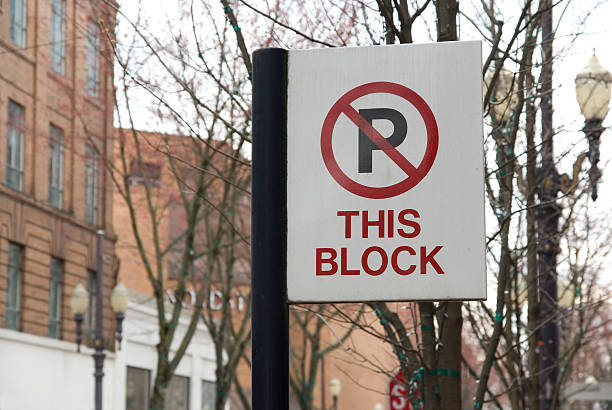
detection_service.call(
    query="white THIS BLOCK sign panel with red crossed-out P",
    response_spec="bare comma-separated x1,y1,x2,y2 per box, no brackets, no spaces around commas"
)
287,41,486,303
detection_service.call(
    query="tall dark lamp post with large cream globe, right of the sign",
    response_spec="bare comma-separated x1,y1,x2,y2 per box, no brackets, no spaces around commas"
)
537,54,612,410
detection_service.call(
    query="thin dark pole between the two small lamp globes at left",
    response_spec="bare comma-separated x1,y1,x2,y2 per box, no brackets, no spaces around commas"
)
93,230,106,410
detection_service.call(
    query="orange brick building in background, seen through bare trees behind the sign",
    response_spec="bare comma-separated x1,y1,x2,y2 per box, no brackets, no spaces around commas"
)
113,130,400,410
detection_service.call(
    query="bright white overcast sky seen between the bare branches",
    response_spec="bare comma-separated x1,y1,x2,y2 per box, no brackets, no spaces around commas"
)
120,0,612,280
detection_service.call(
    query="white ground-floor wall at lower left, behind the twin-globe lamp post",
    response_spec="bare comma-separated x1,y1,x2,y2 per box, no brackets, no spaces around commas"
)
0,304,215,410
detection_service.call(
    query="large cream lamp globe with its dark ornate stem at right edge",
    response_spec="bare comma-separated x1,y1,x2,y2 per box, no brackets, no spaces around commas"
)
576,54,612,201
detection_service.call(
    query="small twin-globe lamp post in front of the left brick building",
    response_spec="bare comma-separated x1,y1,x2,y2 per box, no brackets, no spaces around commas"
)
70,230,128,410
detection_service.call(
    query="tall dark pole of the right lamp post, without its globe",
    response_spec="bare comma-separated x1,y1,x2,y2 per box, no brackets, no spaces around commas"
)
536,0,561,410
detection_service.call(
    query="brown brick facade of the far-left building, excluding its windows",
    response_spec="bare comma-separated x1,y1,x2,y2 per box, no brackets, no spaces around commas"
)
0,0,115,341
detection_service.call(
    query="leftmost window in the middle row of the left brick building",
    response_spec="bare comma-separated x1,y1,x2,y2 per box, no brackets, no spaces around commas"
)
6,100,25,191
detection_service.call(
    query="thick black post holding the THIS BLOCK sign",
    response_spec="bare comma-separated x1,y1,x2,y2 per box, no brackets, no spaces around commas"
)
251,48,289,410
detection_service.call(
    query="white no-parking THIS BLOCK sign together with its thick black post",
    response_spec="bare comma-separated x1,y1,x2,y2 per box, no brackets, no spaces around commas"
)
251,42,486,409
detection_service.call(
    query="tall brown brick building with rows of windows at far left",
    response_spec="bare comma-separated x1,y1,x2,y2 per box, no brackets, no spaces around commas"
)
0,0,120,409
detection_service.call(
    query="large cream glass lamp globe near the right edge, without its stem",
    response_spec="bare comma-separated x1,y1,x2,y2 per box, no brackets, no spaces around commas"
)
576,54,612,121
